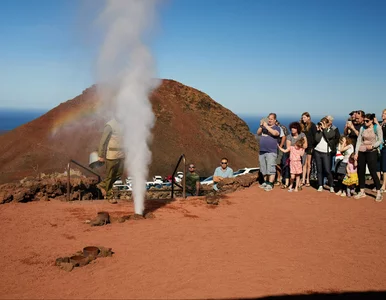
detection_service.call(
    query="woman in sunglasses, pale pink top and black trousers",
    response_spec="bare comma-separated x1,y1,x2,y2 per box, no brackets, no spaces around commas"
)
355,114,383,202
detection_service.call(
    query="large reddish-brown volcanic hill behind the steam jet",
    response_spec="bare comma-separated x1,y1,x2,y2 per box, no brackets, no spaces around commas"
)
0,80,258,183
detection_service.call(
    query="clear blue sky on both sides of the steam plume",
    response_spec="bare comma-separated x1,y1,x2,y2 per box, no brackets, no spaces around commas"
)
0,0,386,116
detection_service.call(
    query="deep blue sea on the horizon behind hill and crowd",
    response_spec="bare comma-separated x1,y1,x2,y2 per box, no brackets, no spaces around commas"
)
0,108,347,134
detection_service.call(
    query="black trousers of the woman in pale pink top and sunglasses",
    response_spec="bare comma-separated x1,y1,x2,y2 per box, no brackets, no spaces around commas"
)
358,150,381,191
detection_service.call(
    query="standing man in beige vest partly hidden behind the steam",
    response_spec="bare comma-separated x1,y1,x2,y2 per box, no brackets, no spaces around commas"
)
97,118,125,204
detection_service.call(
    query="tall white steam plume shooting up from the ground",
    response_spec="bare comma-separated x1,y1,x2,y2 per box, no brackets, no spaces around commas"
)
97,0,159,214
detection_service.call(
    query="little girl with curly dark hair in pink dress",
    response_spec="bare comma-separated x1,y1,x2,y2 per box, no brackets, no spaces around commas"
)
278,138,304,192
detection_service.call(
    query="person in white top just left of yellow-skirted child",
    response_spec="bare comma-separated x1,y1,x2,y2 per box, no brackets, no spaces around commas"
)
335,136,354,197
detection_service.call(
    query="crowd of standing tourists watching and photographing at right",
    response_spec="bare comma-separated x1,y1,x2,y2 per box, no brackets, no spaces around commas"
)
257,109,386,202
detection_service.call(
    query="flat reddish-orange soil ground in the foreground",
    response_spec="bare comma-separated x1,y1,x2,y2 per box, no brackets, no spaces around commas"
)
0,186,386,299
